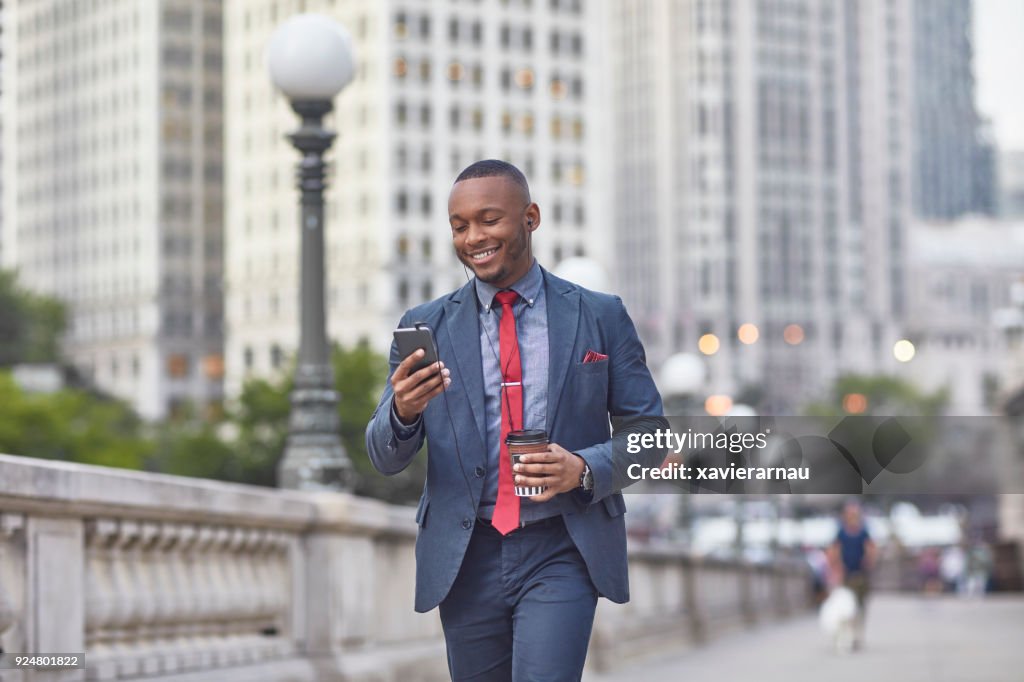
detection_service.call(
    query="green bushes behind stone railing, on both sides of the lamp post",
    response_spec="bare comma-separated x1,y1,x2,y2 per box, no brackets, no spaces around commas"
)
0,331,426,502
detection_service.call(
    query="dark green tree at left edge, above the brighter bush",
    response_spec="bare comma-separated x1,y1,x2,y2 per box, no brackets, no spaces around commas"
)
0,270,66,367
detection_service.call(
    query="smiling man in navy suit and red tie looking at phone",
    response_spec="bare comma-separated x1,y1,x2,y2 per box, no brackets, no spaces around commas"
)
367,161,668,680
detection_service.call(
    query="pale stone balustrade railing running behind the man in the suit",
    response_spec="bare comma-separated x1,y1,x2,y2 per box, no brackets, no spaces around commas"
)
0,455,807,682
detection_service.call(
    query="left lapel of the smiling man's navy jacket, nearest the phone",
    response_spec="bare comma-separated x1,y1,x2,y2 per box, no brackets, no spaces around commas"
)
444,283,486,443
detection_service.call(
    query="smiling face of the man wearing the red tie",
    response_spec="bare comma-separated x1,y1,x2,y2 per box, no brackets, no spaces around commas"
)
449,176,541,289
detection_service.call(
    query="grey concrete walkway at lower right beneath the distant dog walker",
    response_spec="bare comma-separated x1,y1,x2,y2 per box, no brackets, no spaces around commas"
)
584,594,1024,682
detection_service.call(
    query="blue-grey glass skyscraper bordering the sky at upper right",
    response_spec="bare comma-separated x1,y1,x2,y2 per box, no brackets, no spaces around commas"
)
913,0,996,219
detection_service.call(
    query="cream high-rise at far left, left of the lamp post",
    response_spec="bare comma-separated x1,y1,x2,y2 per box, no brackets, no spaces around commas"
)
2,0,223,418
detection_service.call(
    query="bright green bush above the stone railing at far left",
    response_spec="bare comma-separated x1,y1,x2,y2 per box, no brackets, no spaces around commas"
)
0,371,153,469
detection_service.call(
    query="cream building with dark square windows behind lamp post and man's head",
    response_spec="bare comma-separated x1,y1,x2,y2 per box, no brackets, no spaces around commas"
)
225,0,610,393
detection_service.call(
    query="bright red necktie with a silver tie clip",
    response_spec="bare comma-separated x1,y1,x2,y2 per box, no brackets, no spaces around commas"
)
490,291,522,536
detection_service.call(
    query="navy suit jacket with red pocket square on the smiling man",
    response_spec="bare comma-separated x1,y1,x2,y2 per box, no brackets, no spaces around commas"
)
367,268,669,612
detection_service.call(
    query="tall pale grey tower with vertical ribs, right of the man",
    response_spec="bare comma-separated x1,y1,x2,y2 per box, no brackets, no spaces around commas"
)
609,0,911,413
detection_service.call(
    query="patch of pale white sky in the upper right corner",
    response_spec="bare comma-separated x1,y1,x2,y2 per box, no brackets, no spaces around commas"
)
974,0,1024,151
